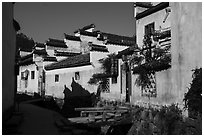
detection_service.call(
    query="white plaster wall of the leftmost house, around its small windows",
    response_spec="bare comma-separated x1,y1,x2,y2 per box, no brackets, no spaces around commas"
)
18,64,38,93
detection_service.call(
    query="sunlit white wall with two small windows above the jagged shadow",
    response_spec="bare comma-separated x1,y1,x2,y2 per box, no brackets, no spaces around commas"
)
45,65,97,98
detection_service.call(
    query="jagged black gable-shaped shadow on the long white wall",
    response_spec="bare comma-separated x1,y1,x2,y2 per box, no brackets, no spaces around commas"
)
61,78,96,117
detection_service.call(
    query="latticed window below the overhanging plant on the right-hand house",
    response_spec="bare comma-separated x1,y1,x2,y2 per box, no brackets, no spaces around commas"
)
142,73,157,97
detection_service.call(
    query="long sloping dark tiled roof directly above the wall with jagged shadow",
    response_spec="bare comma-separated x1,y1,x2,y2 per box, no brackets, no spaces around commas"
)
45,53,91,70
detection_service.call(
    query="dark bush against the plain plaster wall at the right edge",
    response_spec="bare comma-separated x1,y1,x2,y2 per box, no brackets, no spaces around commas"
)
184,68,202,116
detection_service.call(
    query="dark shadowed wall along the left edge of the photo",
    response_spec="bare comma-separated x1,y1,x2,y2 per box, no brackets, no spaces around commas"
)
2,2,16,121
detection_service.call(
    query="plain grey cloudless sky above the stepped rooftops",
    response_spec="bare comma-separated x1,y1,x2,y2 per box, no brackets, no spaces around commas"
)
14,2,135,43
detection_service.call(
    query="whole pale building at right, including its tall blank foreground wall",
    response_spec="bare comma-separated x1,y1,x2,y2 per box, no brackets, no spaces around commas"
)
117,2,202,107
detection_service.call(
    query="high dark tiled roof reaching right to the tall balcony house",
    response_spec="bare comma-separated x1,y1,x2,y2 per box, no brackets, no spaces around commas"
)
98,32,135,46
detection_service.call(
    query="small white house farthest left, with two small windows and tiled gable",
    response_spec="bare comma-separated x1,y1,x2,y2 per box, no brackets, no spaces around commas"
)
17,43,57,94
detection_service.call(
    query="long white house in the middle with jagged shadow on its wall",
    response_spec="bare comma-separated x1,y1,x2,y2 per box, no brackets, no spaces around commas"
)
45,24,135,99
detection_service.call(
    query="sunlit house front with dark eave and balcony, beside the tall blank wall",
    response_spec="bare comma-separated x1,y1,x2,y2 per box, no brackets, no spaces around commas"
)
131,2,172,104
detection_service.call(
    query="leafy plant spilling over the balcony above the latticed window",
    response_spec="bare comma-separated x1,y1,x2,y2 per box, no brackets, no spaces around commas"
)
131,35,171,87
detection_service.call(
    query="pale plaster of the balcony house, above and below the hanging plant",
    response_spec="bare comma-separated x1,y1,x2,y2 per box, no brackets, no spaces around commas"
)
131,4,172,104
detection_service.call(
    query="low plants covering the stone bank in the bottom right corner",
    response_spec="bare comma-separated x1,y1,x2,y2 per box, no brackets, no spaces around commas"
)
128,104,202,135
